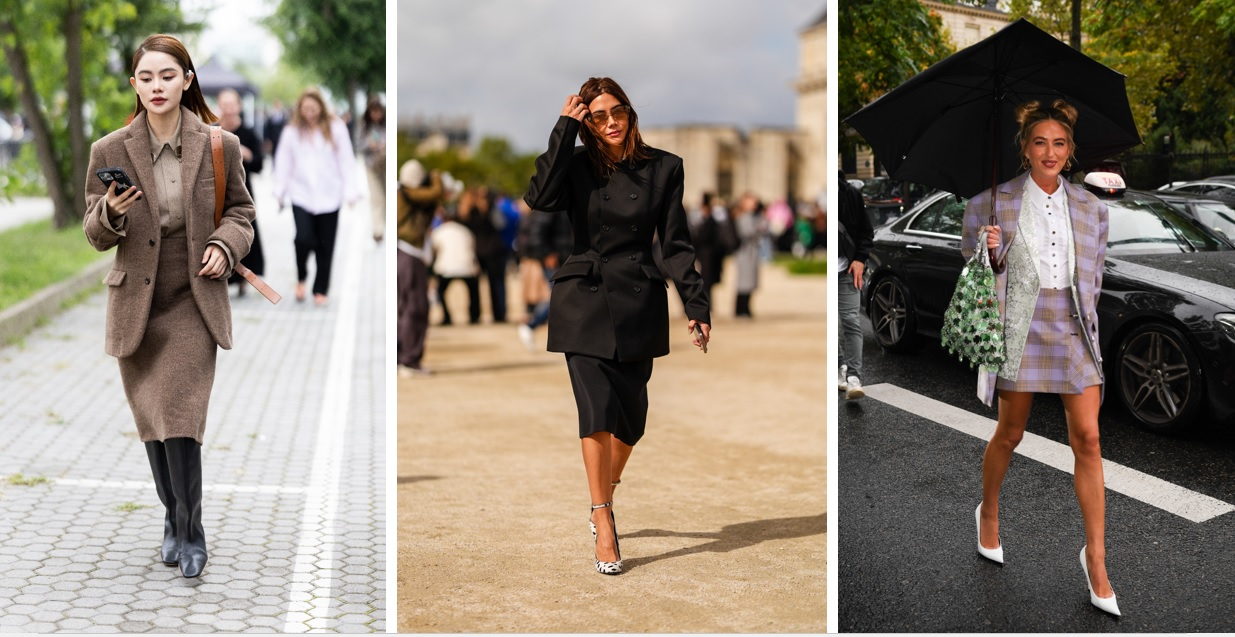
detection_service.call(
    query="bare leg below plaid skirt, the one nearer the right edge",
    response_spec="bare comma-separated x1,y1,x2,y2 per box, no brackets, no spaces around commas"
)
1060,385,1114,597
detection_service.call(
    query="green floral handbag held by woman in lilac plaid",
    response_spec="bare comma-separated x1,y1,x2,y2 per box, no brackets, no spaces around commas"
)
940,232,1004,370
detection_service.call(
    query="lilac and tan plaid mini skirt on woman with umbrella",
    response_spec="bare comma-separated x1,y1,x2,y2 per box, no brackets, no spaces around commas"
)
995,288,1102,394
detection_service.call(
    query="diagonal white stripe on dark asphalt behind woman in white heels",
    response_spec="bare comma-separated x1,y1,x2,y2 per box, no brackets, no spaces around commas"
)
866,383,1235,522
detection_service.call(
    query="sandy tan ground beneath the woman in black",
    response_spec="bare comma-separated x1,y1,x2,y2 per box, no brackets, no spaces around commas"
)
398,259,830,633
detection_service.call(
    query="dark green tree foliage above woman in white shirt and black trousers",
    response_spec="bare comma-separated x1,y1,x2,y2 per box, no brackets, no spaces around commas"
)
263,0,385,124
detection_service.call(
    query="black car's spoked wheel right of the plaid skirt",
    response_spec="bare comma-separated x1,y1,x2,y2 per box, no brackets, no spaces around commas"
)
1115,323,1204,433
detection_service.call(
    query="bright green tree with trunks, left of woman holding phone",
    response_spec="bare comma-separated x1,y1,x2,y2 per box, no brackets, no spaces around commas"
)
0,0,193,227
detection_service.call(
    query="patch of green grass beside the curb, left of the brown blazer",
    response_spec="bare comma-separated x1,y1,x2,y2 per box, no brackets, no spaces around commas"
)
0,220,103,310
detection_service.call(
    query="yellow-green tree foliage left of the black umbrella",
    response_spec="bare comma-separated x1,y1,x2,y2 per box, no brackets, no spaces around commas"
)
837,0,952,152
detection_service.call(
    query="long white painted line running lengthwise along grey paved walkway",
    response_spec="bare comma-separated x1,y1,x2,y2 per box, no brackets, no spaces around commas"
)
283,205,368,632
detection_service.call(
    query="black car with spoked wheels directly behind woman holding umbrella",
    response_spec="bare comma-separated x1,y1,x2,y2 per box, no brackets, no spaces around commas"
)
863,174,1235,432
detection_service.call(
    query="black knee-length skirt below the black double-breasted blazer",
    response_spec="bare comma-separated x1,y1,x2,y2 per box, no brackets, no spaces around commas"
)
566,353,652,447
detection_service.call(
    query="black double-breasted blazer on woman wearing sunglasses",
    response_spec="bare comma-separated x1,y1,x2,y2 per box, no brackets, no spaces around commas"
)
524,116,711,360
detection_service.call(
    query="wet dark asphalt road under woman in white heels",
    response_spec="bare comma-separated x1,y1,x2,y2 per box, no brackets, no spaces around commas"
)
834,320,1235,632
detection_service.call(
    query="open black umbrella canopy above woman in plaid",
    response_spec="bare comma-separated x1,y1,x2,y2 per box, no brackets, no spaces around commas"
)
845,19,1141,198
